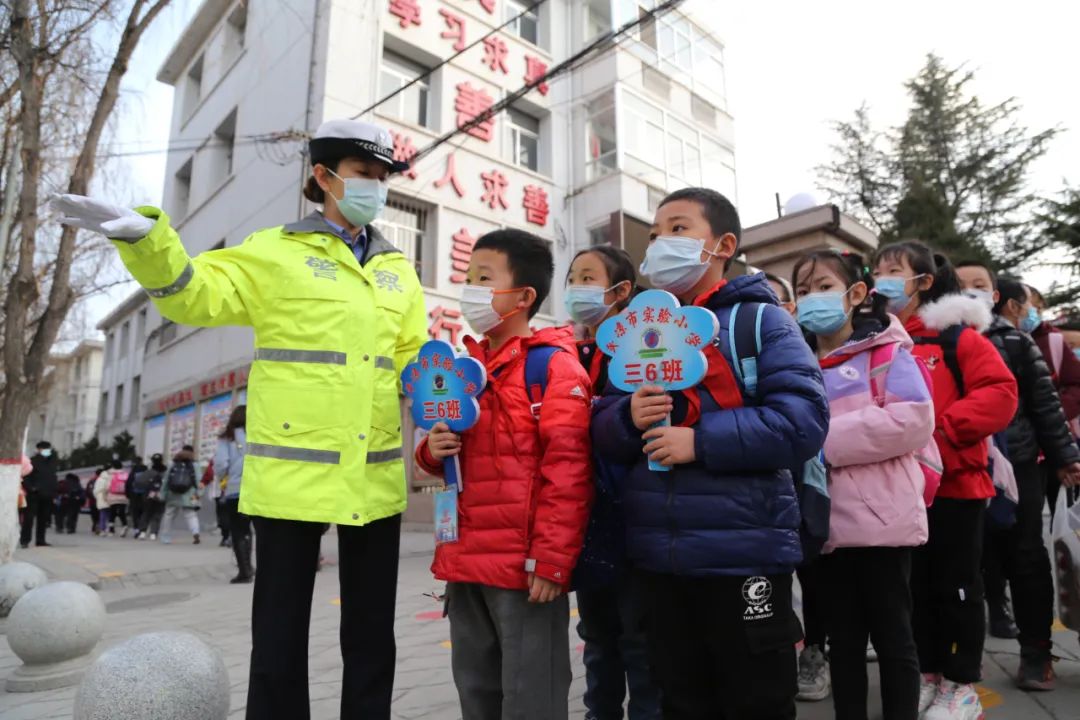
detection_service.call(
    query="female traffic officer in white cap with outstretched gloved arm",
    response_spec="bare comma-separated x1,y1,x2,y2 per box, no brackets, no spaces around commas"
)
54,121,426,720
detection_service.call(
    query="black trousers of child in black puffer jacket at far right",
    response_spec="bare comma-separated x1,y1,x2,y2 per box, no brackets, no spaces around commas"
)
983,462,1054,648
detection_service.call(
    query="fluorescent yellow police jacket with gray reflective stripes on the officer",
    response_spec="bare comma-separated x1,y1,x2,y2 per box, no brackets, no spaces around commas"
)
116,207,427,525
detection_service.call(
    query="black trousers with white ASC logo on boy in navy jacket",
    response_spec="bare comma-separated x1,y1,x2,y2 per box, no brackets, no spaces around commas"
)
639,572,799,720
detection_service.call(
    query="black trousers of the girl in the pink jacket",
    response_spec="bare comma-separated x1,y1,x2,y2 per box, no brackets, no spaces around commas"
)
821,547,919,720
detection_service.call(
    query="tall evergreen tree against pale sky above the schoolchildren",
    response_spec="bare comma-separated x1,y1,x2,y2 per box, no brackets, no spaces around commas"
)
819,54,1058,271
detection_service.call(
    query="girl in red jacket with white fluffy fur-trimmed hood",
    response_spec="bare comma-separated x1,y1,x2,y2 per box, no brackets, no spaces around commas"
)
874,242,1016,720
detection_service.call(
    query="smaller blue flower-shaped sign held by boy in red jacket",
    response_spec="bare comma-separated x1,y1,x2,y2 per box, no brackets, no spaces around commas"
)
402,340,487,433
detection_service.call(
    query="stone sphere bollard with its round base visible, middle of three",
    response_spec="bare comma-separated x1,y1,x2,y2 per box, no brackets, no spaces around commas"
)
6,582,105,693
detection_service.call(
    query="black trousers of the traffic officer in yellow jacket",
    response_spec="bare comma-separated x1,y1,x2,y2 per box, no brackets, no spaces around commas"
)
246,515,401,720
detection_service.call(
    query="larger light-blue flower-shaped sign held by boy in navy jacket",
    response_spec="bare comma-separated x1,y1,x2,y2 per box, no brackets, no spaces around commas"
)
596,290,719,393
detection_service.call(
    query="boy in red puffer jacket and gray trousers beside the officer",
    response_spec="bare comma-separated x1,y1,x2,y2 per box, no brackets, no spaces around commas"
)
416,230,593,720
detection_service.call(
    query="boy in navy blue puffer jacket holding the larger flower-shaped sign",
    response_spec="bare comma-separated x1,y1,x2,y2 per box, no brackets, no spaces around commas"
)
592,188,828,720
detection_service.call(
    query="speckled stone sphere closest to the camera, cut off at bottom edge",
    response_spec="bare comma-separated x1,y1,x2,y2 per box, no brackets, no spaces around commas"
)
73,631,229,720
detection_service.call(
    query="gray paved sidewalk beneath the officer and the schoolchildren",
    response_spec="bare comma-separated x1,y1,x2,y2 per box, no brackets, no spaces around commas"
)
0,530,1080,720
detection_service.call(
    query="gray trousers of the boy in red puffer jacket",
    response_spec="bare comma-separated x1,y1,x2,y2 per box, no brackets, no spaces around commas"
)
446,583,571,720
